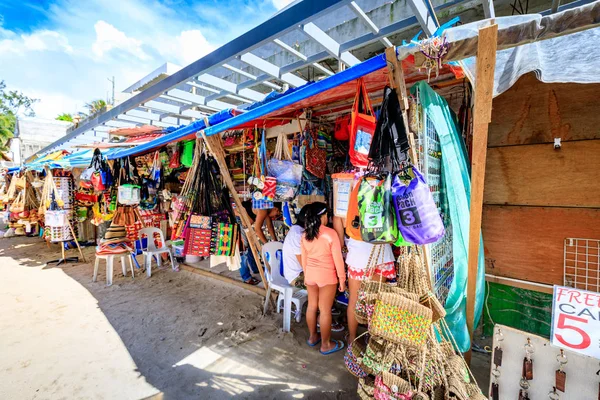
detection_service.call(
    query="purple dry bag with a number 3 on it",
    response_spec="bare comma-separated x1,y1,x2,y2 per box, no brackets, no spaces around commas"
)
392,166,445,244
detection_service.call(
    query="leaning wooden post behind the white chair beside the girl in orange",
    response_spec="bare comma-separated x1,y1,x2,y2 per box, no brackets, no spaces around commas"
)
200,131,269,289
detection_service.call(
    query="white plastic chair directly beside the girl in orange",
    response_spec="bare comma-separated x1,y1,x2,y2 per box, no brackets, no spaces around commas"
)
262,242,308,332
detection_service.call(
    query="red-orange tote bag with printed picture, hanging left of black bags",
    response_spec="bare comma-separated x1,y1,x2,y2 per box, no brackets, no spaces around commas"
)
349,78,377,167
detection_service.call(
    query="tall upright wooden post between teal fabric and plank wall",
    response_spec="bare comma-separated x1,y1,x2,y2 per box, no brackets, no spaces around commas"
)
466,24,498,361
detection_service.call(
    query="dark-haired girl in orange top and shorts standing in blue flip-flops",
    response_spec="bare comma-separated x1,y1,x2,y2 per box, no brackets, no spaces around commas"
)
301,203,346,355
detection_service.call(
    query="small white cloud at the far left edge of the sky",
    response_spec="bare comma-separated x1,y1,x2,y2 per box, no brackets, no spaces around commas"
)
0,29,73,54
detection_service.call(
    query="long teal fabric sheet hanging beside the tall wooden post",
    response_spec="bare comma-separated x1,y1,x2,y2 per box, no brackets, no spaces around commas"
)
411,81,485,352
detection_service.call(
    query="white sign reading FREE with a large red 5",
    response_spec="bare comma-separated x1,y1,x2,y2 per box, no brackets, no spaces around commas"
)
550,286,600,359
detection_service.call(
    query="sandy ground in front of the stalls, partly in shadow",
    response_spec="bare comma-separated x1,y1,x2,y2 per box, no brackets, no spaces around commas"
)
0,238,489,399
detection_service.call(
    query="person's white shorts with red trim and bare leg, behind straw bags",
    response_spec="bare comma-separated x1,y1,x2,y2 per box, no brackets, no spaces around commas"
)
346,238,396,343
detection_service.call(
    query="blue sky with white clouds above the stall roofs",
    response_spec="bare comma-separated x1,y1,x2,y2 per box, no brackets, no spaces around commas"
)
0,0,291,118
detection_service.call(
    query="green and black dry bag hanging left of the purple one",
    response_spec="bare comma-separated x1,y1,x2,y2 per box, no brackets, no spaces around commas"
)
358,173,398,243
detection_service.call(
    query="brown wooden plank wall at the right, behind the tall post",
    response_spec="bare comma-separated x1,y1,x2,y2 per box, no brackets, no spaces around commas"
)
482,74,600,284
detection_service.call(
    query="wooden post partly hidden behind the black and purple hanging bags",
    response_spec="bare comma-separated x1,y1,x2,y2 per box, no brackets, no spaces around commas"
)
385,46,433,290
